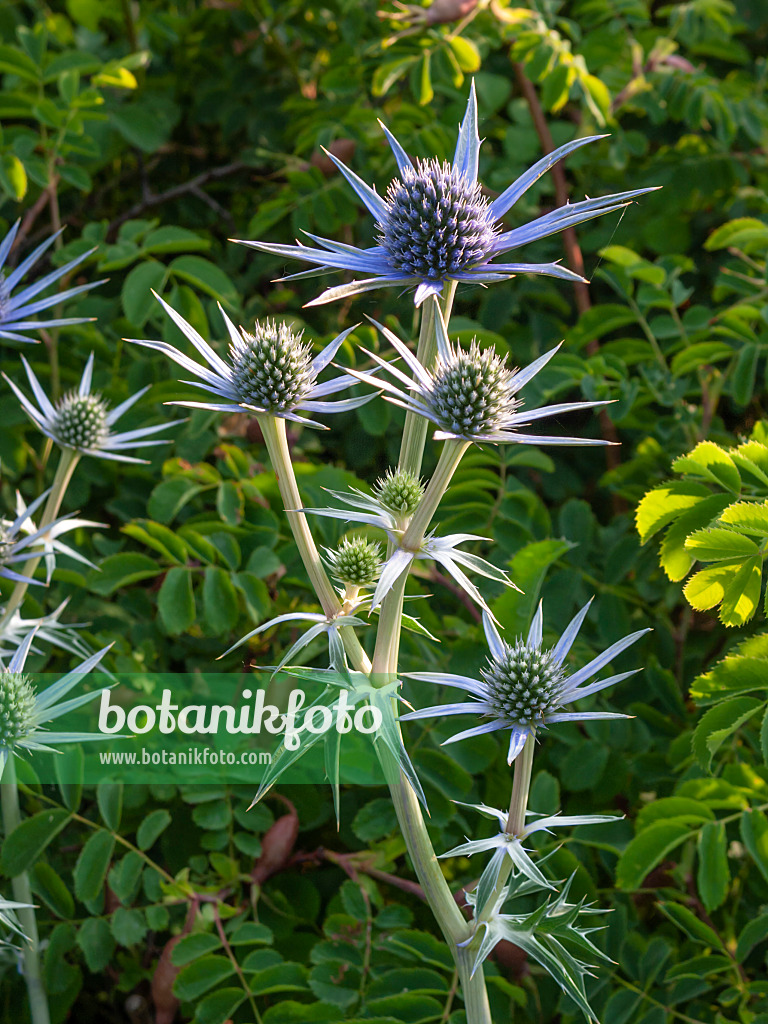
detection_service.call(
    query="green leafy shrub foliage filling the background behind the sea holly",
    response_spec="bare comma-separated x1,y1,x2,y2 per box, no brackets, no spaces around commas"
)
0,0,768,1024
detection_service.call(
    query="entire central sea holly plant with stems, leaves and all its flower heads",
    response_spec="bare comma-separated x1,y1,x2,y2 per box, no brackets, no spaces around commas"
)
139,83,648,1024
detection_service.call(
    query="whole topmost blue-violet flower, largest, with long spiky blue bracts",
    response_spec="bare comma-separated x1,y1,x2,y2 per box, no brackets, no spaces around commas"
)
232,83,653,306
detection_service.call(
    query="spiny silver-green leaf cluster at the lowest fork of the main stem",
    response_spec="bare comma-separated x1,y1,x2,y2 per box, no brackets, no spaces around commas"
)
460,874,610,1021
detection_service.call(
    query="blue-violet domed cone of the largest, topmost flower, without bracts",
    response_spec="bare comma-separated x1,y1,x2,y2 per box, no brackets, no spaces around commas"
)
379,160,500,281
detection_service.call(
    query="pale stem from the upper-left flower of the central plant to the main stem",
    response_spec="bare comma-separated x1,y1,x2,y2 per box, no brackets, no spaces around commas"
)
258,416,371,672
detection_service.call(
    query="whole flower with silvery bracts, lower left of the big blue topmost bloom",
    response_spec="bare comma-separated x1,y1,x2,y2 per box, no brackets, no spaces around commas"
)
127,295,375,430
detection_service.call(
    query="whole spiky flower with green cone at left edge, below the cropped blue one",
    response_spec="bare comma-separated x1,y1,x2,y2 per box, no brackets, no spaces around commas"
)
3,352,183,463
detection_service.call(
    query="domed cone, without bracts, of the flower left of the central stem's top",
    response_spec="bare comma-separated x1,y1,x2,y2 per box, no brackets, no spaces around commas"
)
229,321,313,412
